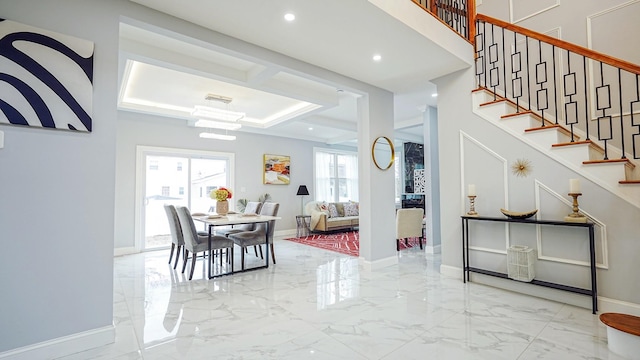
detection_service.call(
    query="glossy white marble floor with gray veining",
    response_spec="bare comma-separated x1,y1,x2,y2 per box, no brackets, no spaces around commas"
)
58,240,620,360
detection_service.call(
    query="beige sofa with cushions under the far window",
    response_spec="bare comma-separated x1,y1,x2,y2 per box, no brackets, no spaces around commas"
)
304,201,360,232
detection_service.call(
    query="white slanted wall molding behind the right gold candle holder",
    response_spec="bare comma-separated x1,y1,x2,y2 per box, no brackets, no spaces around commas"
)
535,179,609,269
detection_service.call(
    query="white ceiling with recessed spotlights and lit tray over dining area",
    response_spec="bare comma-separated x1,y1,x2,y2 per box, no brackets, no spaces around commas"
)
119,0,466,144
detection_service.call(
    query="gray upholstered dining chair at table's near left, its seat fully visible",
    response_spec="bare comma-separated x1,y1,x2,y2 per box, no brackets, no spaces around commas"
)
176,206,233,280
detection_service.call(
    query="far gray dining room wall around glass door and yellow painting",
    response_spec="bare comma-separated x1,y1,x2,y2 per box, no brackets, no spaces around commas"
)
115,111,357,248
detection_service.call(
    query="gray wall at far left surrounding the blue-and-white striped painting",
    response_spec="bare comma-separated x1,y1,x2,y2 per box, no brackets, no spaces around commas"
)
0,0,120,354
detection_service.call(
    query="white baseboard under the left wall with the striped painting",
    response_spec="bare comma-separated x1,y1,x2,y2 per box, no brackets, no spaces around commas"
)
0,325,116,360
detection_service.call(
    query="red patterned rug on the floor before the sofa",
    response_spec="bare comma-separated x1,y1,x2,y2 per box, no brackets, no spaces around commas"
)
284,231,424,256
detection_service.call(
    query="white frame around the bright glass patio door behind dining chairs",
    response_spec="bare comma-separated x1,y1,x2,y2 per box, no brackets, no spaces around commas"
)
134,145,236,252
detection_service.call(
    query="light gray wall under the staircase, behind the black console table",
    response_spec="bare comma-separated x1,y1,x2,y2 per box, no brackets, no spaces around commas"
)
436,64,640,306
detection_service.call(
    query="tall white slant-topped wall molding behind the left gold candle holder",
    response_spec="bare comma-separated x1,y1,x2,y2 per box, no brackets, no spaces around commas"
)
460,130,509,255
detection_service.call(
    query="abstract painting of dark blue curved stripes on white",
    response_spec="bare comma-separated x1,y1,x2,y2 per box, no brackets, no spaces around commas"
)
0,19,94,132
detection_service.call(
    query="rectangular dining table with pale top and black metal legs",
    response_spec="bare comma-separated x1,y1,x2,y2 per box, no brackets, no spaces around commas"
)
193,213,281,279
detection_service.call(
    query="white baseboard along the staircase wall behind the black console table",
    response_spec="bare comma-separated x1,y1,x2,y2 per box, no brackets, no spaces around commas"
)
440,265,640,316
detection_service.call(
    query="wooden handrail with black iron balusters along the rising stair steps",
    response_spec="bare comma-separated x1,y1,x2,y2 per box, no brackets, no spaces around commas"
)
475,14,640,160
